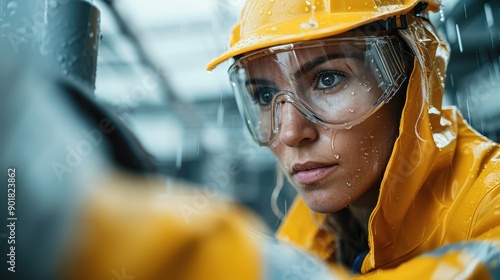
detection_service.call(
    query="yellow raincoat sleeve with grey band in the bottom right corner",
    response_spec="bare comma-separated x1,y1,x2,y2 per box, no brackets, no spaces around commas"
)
356,182,500,280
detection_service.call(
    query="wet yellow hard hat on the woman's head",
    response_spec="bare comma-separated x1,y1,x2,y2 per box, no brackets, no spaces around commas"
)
207,0,441,70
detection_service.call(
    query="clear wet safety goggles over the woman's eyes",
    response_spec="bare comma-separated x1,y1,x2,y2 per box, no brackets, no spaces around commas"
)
228,35,409,146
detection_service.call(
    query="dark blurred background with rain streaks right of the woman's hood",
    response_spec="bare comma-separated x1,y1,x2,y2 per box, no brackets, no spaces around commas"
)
438,0,500,142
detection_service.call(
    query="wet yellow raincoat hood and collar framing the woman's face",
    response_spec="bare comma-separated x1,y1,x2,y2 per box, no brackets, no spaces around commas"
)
277,16,500,273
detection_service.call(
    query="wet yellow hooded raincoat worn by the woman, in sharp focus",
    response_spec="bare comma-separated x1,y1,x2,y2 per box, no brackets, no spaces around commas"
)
277,14,500,279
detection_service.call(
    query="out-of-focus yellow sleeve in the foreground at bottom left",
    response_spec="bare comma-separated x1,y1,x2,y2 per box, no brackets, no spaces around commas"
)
60,174,262,280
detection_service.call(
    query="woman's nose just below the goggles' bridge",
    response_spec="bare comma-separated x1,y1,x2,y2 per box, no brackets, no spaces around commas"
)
278,102,318,147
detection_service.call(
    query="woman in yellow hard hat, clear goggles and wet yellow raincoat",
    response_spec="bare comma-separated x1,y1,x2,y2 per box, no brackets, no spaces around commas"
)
208,0,500,279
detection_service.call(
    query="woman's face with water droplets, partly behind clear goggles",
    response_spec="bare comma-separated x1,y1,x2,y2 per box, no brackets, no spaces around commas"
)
248,44,402,213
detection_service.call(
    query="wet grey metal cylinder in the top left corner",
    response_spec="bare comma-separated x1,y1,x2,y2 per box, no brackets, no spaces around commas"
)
0,0,100,89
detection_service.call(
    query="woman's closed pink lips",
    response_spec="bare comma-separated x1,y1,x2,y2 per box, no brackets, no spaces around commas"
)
292,162,337,185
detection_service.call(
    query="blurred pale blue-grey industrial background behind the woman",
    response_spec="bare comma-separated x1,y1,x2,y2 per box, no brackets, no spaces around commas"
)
0,0,500,229
